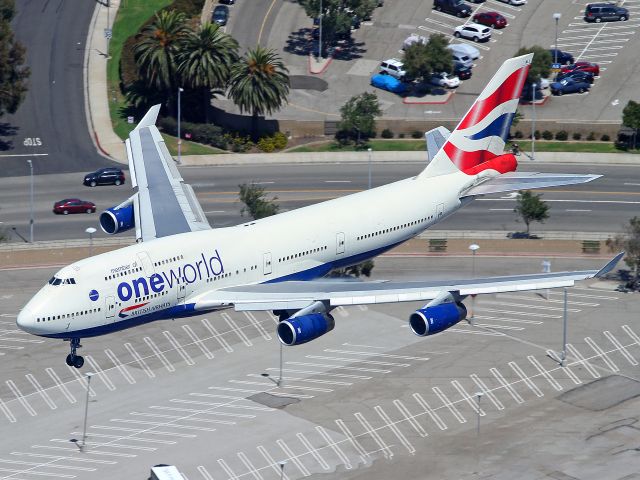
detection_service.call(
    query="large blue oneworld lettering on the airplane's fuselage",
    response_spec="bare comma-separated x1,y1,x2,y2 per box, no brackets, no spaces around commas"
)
117,250,224,302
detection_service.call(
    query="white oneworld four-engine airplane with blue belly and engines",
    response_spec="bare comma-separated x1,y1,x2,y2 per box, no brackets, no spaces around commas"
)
17,55,622,368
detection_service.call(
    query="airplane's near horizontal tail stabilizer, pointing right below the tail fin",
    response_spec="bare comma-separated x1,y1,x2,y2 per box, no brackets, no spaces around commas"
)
462,172,602,197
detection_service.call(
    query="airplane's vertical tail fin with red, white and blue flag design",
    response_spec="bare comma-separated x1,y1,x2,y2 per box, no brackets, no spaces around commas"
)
424,54,533,176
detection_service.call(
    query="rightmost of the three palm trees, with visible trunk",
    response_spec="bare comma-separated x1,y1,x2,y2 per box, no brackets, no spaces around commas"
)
229,46,289,140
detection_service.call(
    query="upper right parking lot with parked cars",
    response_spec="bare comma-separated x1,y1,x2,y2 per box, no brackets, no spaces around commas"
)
221,0,640,127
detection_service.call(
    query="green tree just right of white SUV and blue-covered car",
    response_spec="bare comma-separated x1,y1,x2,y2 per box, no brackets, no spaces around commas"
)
403,33,453,82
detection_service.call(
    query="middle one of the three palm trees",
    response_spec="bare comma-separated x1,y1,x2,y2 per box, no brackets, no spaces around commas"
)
176,23,238,119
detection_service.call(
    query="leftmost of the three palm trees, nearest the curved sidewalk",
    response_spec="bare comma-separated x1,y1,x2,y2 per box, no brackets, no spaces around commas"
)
134,10,188,91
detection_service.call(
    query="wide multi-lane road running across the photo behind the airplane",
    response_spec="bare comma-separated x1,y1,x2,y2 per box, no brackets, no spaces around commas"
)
0,162,640,241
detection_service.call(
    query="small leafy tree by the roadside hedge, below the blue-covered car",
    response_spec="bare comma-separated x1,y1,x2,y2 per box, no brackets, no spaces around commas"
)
338,92,382,145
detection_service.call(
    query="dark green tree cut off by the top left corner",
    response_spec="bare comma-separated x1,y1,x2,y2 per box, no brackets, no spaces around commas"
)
0,0,31,115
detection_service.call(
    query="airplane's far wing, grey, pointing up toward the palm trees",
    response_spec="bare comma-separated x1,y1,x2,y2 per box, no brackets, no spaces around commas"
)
125,105,211,242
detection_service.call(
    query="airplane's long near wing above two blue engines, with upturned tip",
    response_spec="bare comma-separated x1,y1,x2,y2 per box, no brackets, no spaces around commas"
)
192,253,624,311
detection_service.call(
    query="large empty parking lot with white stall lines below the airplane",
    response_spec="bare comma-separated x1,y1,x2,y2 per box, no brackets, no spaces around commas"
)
0,257,640,480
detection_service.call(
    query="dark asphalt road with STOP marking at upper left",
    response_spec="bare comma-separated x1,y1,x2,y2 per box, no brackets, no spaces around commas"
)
0,0,115,177
